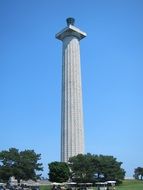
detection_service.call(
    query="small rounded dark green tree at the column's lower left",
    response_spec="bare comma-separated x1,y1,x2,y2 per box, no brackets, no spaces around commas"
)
48,162,70,183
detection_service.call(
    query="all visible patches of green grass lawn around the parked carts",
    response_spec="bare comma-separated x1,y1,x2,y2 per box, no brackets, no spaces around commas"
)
40,180,143,190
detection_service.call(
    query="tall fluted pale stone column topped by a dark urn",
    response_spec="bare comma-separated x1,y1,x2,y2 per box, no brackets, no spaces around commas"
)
56,18,86,162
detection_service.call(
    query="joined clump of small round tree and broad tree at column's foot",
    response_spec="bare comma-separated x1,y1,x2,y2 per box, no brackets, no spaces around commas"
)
49,154,125,183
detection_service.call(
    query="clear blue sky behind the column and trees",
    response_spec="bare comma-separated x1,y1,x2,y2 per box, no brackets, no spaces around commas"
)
0,0,143,176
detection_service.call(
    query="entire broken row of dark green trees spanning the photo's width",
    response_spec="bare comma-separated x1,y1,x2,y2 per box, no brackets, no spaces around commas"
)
0,148,143,183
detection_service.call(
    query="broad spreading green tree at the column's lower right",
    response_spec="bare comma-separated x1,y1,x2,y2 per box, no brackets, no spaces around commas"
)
69,154,125,182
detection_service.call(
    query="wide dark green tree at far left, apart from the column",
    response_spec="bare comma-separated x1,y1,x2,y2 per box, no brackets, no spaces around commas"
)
0,148,43,181
